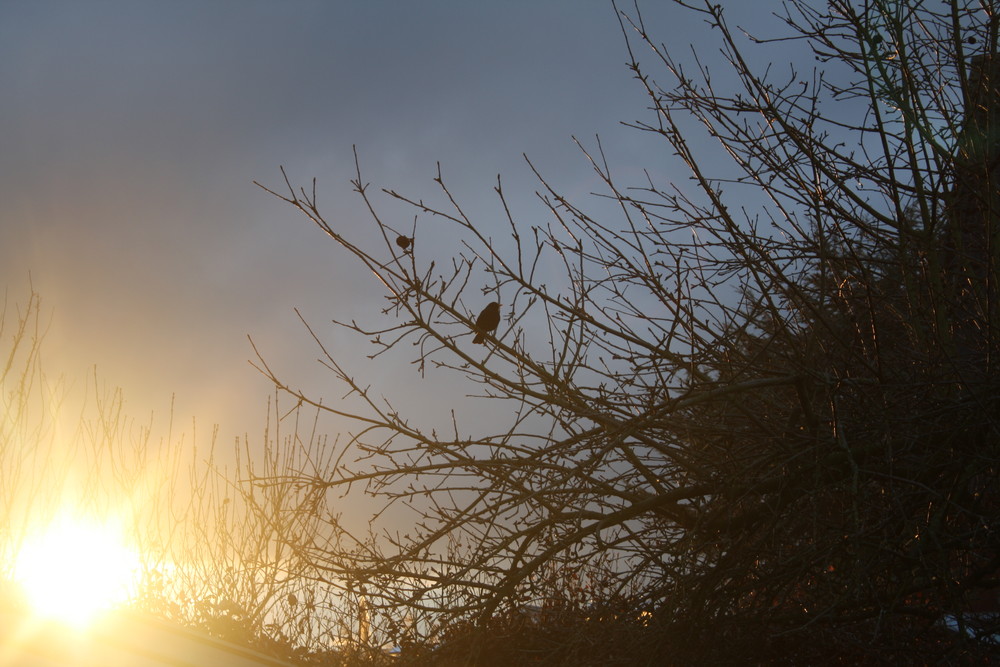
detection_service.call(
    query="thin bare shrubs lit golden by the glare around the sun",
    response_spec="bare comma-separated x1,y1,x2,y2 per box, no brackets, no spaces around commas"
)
0,290,358,664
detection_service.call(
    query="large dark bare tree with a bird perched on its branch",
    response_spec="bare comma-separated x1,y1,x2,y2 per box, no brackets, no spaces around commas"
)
259,0,1000,659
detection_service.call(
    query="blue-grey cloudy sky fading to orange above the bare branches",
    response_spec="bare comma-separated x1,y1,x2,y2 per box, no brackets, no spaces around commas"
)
0,0,764,448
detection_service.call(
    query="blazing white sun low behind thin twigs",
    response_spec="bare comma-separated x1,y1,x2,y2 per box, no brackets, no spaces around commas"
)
14,516,139,626
